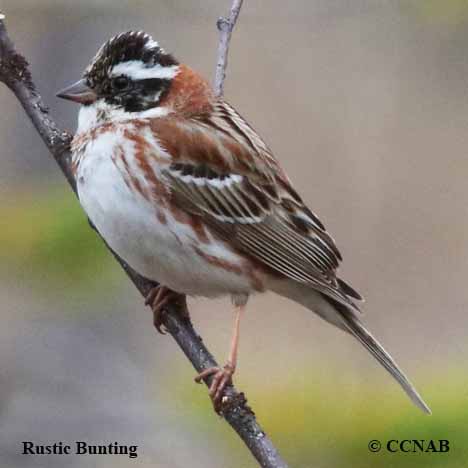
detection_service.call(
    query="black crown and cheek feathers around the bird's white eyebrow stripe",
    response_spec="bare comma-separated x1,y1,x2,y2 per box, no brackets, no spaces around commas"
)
84,31,179,112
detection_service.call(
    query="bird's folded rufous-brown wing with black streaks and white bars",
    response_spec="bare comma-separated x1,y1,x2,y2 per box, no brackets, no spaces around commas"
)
154,102,360,309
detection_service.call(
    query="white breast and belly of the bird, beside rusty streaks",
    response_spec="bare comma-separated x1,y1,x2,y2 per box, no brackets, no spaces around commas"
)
74,116,252,296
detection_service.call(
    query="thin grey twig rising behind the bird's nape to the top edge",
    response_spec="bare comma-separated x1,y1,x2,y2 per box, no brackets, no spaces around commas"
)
213,0,244,97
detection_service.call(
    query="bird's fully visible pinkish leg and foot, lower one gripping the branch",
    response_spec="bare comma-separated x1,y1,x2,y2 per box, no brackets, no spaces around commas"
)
195,304,245,412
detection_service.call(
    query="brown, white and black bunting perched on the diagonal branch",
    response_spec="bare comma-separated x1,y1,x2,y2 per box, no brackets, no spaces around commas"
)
57,31,431,414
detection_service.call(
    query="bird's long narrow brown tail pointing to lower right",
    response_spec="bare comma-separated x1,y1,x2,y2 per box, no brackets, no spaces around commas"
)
270,281,431,414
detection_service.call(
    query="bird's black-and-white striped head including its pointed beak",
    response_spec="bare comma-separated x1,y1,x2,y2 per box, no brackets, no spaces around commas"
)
57,31,180,113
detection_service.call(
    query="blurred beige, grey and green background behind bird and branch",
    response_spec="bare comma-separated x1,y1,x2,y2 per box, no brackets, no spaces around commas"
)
0,0,468,468
